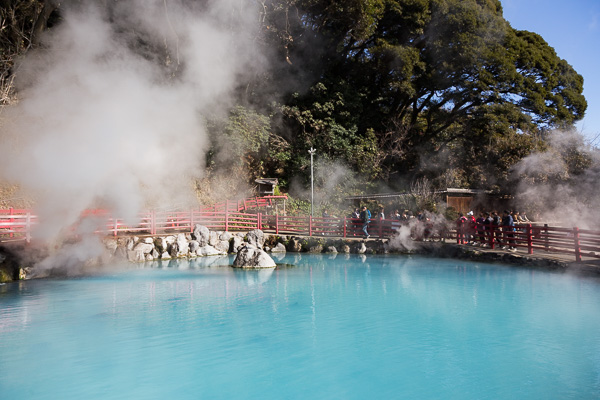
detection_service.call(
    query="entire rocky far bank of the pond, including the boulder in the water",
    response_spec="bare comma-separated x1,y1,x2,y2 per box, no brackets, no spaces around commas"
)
0,225,584,283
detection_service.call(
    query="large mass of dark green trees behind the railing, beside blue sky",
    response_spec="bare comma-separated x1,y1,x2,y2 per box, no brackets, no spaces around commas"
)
251,0,586,195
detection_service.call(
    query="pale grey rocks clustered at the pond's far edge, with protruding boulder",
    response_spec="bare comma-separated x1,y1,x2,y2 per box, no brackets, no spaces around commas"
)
104,225,388,268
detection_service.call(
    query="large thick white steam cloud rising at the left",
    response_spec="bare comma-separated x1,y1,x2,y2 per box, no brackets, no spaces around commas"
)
0,0,263,239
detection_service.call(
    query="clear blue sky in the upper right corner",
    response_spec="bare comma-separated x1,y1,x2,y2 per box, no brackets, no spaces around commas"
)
501,0,600,147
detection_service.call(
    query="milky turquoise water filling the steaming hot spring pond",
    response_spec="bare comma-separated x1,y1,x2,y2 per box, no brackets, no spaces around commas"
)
0,255,600,399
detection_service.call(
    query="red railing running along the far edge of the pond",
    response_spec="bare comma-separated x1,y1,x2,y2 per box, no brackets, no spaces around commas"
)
0,206,600,261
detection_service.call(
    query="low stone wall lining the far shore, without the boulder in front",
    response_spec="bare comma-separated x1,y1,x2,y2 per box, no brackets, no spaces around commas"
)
0,225,592,282
